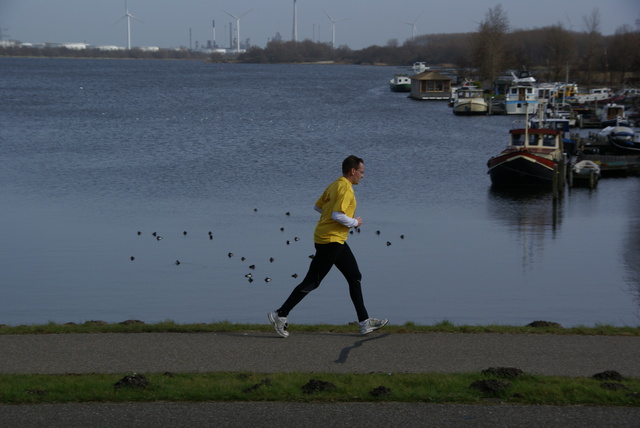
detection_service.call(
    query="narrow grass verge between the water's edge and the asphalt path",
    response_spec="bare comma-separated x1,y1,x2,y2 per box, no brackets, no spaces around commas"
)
0,320,640,336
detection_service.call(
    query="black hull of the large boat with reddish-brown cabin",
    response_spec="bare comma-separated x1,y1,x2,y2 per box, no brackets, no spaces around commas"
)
487,150,558,187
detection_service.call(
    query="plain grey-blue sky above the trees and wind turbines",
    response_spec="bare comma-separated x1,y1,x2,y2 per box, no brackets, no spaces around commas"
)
0,0,640,49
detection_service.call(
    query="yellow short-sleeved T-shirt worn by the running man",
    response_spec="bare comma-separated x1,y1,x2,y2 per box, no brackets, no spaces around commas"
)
313,177,356,244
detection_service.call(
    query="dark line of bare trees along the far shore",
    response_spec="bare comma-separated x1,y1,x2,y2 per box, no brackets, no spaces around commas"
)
0,4,640,88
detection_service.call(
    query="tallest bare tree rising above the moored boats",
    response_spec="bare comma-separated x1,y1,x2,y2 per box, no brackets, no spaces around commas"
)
473,4,509,87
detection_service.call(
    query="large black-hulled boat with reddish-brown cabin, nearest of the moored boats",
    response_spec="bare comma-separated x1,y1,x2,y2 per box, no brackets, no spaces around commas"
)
487,125,563,187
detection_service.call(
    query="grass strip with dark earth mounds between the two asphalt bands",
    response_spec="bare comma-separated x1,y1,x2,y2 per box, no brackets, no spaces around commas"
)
0,373,640,407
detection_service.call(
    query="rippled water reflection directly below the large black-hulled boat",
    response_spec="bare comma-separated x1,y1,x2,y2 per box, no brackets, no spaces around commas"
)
487,186,562,271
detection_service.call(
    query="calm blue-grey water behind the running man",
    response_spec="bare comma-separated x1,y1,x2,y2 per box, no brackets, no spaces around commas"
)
0,59,640,326
